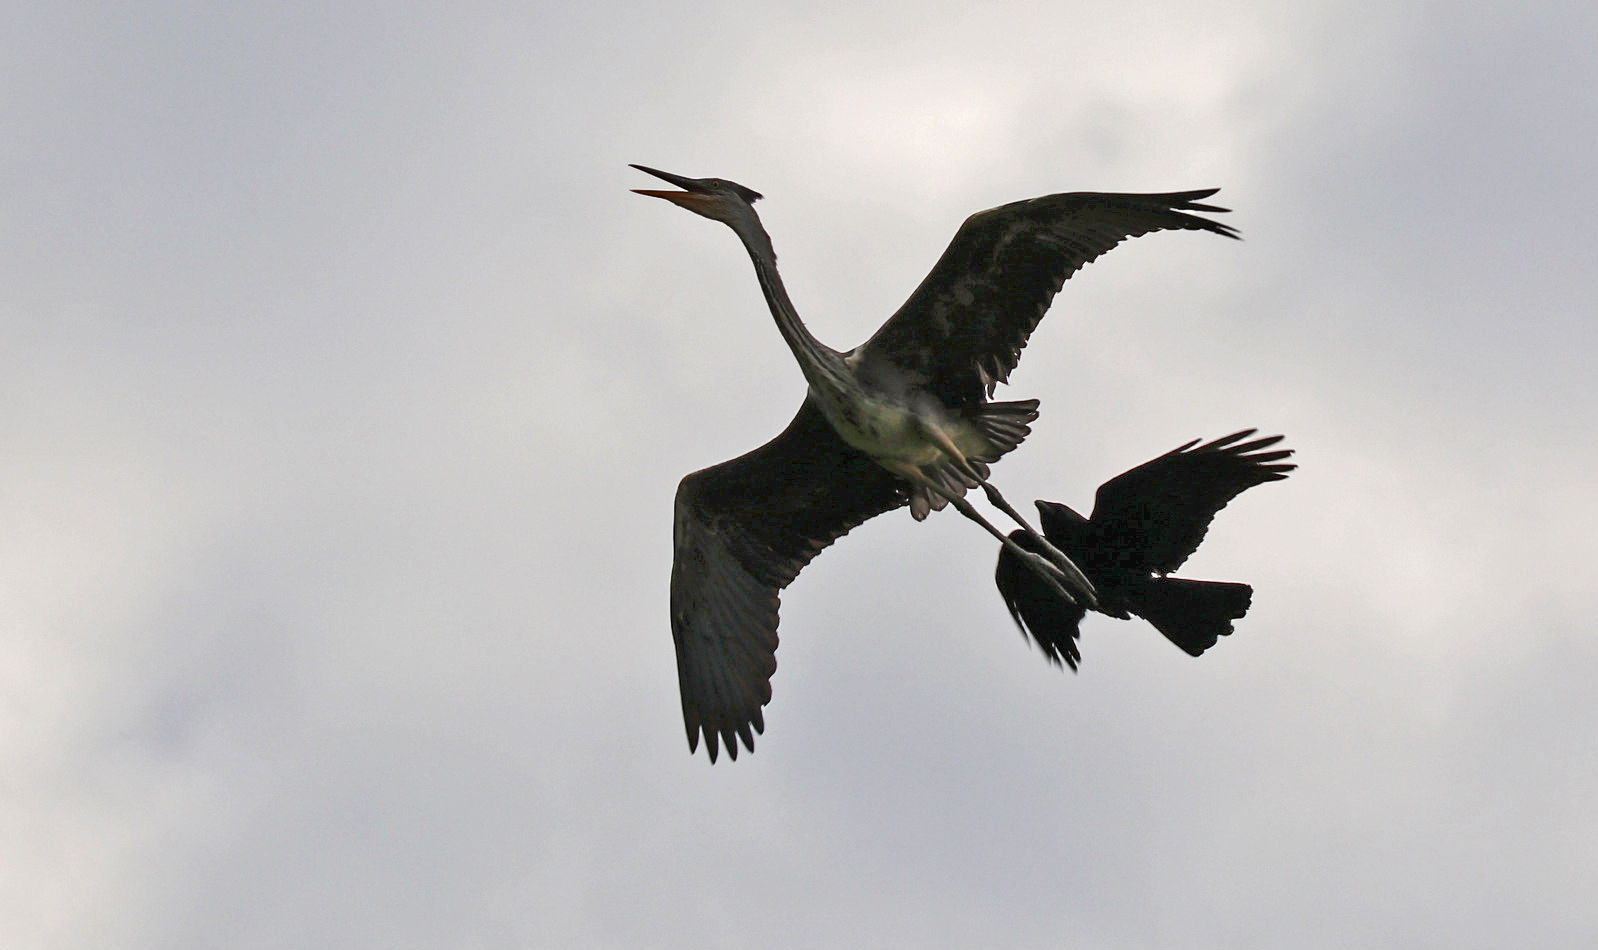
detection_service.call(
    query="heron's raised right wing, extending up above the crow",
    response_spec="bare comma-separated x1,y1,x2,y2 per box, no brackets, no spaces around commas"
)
861,189,1237,406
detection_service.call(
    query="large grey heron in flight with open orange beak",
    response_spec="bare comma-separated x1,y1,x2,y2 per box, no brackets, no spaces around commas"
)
633,165,1237,761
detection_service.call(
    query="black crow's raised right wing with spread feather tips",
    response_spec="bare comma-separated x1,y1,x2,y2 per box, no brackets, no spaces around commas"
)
1086,429,1298,574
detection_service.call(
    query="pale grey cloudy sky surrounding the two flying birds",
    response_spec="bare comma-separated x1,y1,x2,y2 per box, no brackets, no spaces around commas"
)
0,0,1598,950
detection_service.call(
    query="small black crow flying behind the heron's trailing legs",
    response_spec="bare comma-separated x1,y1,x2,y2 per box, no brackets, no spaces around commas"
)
994,429,1298,670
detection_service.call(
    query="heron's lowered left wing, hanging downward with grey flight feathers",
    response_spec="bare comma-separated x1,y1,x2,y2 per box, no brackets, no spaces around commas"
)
671,398,909,761
